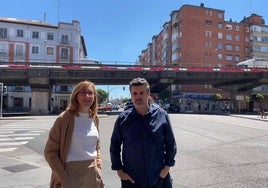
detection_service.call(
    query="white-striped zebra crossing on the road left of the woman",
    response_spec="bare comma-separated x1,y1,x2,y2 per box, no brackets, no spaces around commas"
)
0,117,52,154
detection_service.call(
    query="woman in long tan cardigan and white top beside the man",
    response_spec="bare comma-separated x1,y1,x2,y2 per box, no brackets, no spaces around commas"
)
44,81,102,188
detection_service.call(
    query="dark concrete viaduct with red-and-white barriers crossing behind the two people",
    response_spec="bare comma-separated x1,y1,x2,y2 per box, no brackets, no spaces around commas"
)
0,64,268,115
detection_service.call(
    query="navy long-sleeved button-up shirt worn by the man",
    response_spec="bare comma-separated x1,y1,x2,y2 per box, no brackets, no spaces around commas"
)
110,105,177,186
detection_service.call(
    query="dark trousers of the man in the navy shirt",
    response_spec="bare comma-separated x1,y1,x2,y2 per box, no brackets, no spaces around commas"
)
121,174,172,188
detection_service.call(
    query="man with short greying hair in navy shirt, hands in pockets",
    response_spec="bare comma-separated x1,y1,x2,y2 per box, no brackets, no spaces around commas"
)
110,78,177,188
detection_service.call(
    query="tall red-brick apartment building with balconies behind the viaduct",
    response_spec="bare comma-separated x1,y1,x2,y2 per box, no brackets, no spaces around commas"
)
139,3,268,110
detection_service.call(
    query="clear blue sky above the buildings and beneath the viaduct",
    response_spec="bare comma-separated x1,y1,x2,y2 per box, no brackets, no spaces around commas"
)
0,0,268,99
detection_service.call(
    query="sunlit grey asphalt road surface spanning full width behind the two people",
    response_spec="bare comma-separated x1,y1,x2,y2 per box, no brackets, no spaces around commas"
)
0,114,268,188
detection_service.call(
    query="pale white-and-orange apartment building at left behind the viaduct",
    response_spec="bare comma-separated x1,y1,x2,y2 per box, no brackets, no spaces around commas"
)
0,18,87,112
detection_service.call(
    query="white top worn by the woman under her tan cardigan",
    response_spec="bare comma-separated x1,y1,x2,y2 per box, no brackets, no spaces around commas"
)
66,113,99,162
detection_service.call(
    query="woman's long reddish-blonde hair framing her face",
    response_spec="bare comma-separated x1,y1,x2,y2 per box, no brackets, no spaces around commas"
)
66,80,98,118
